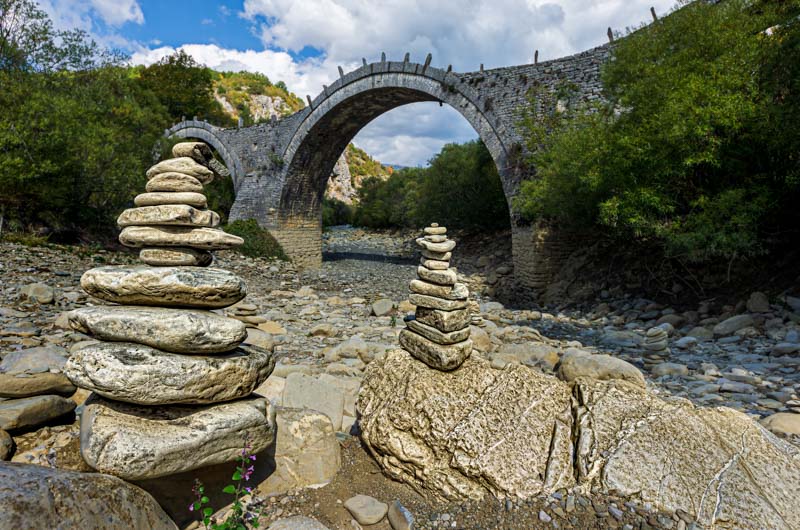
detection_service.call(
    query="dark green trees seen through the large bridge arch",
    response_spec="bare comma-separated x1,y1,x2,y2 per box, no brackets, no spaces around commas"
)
353,140,509,230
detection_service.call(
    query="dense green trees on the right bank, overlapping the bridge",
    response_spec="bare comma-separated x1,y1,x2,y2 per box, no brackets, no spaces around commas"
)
516,0,800,261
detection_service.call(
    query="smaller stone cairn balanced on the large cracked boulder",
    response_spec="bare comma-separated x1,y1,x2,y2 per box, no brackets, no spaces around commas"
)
400,223,472,371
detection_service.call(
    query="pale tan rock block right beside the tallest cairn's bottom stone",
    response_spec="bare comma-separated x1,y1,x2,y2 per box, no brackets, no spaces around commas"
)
258,407,341,495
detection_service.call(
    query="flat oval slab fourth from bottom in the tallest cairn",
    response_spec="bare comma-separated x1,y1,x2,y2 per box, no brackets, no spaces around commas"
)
81,266,247,308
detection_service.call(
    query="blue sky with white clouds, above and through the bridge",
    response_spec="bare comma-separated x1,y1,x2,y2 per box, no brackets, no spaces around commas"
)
39,0,675,166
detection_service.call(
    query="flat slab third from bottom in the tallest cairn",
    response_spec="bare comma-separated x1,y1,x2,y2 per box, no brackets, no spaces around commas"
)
68,306,247,355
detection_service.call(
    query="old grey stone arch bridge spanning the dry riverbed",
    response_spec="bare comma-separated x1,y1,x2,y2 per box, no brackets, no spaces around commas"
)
164,45,609,288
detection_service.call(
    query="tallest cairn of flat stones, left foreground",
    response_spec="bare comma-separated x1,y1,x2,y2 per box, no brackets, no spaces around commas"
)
65,142,275,480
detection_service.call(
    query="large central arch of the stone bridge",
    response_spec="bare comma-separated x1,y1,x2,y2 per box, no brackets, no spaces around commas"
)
273,62,519,266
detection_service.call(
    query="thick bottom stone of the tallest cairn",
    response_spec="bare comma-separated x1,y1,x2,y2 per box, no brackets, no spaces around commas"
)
81,395,275,480
